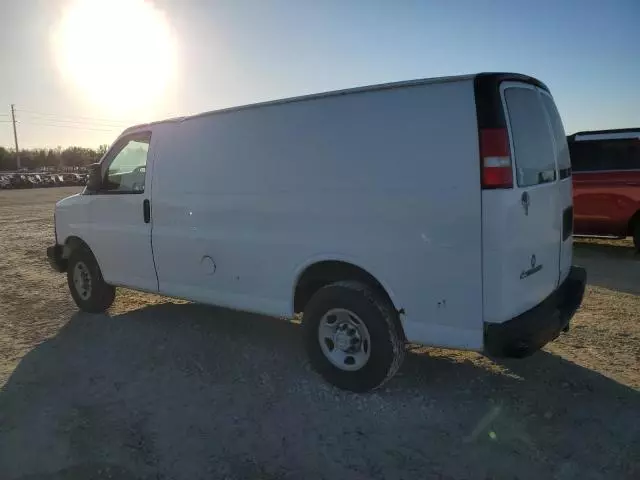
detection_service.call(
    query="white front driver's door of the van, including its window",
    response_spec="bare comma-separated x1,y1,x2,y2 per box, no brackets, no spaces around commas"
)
87,132,158,292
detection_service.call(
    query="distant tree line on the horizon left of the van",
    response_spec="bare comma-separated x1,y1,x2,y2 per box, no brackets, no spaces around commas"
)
0,145,108,171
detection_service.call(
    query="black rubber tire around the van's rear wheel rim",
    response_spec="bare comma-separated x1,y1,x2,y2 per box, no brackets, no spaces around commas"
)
302,281,405,392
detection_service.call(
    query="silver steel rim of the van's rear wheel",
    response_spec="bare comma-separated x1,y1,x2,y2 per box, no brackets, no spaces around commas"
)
318,308,371,371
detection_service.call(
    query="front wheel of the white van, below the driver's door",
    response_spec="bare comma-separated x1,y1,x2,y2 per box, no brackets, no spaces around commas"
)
67,246,116,313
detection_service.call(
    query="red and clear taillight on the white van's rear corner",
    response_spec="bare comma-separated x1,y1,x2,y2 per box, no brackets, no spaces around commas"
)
480,128,513,189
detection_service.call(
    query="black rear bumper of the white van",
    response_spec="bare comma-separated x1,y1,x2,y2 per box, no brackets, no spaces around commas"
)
484,266,587,357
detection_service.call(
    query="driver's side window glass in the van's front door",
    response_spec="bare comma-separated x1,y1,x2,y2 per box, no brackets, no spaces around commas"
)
102,135,150,193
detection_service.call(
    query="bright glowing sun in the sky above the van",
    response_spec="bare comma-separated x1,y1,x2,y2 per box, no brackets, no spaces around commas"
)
52,0,177,113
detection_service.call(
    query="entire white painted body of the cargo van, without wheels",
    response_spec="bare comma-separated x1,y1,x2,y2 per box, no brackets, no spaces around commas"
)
48,74,585,350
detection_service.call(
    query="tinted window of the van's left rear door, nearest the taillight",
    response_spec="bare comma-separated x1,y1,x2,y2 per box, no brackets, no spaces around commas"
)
504,88,556,187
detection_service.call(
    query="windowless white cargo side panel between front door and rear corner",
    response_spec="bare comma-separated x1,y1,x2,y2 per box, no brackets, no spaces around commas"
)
152,78,483,349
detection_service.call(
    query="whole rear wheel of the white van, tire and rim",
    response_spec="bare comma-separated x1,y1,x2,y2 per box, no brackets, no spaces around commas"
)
302,281,405,392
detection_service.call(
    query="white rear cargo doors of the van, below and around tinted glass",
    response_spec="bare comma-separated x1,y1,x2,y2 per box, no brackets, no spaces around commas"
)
482,82,572,323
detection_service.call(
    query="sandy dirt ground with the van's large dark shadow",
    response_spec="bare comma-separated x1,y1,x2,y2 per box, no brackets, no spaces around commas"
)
0,188,640,480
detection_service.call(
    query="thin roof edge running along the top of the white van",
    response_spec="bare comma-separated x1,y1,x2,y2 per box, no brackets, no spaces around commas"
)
121,72,549,135
